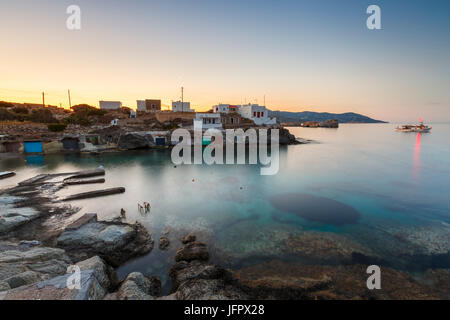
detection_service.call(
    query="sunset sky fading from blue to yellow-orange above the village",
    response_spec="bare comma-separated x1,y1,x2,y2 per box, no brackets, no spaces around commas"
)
0,0,450,122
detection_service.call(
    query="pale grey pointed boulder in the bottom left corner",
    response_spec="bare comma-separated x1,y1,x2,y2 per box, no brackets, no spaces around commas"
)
0,257,117,300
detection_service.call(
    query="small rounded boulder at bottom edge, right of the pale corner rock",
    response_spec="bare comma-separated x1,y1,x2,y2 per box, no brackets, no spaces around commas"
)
117,272,161,300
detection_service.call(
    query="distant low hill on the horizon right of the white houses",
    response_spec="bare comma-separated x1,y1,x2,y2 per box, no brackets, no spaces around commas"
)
269,111,386,123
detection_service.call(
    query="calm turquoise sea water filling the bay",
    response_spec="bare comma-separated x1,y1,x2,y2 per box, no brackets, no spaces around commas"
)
0,124,450,288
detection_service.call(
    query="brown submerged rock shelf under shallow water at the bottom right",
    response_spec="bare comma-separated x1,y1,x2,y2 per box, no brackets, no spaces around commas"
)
233,261,442,300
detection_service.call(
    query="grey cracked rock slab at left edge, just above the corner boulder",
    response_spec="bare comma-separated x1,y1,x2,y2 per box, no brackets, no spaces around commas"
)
0,245,71,291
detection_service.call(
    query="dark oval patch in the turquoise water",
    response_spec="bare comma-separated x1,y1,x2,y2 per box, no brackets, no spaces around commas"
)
270,193,360,226
